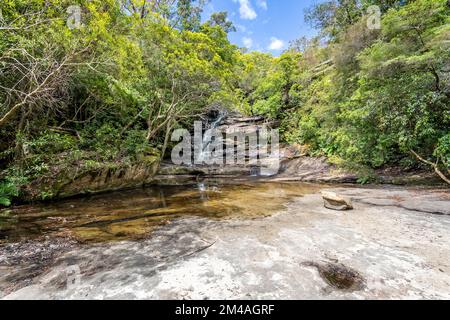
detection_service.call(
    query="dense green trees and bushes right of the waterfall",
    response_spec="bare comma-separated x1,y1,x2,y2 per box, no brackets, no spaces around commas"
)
272,0,450,180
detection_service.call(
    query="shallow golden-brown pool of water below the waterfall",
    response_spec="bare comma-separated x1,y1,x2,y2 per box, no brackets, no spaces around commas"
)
0,182,320,242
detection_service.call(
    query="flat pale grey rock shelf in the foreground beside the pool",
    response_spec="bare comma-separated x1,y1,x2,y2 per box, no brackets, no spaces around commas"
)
0,187,450,299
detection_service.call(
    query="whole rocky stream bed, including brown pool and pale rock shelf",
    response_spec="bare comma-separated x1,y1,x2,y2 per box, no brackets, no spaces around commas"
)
0,117,450,299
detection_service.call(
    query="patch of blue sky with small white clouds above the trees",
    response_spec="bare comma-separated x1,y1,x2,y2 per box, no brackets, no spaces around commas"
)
204,0,319,55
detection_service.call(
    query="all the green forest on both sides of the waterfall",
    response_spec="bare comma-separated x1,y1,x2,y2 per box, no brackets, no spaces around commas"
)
0,0,450,192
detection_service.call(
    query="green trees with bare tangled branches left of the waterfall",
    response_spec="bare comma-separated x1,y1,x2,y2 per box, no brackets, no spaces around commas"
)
0,0,240,192
